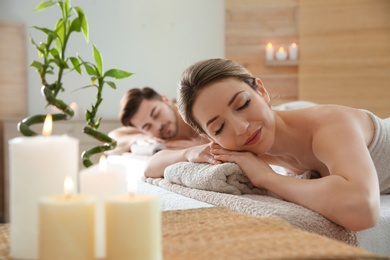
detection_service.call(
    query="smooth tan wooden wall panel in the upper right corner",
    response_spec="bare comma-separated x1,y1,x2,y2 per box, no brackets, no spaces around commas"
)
299,0,390,117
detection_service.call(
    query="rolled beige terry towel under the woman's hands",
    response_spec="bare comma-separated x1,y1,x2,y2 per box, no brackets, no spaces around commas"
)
164,162,270,195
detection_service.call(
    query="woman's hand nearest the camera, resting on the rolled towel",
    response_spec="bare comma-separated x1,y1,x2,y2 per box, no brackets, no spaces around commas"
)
210,143,275,188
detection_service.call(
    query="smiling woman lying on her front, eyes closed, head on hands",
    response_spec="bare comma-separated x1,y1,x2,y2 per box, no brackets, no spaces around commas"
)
178,59,390,231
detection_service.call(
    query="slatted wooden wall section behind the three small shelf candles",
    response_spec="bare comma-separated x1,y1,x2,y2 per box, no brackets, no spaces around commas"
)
225,0,299,103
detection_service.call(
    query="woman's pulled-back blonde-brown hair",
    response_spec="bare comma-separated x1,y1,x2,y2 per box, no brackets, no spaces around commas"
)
177,58,257,134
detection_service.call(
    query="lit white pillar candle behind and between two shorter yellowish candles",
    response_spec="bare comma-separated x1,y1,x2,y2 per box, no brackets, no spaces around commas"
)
80,155,127,259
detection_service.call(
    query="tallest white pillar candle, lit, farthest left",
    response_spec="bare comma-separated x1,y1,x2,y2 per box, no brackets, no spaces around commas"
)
9,116,79,259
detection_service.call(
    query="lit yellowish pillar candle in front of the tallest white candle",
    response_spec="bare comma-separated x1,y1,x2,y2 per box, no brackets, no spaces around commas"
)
39,177,95,260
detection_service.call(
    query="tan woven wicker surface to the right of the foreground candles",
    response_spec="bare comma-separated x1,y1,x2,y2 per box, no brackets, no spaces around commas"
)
163,208,386,260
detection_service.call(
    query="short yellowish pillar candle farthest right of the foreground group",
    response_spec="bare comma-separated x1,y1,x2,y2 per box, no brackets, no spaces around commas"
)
106,194,162,260
